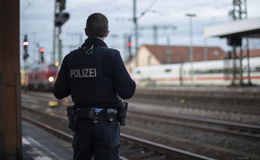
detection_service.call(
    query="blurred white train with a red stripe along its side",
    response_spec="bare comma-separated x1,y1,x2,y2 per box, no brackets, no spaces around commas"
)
132,57,260,85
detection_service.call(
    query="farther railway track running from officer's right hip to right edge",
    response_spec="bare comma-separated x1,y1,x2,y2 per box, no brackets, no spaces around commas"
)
128,109,260,141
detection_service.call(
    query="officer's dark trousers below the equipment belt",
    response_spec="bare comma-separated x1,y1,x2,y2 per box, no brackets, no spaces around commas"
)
72,120,120,160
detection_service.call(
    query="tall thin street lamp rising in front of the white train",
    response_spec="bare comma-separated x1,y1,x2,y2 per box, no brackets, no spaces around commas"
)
185,13,196,85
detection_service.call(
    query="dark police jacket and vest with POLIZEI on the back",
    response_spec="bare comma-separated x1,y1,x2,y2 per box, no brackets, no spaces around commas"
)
53,38,136,107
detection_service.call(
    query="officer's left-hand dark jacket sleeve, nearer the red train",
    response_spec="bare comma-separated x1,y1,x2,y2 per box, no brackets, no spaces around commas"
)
53,56,70,99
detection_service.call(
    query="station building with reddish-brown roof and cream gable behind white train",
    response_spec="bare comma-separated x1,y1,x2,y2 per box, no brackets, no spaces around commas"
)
125,45,227,72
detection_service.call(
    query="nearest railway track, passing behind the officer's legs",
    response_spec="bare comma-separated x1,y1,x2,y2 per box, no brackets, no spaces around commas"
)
23,107,213,160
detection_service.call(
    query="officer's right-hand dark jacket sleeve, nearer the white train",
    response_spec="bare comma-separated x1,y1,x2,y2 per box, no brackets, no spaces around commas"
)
112,51,136,99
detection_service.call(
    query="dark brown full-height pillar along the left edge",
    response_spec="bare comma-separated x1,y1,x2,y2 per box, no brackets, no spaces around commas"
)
0,0,22,160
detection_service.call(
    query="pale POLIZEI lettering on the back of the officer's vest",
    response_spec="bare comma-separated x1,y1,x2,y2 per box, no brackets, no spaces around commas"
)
70,68,97,78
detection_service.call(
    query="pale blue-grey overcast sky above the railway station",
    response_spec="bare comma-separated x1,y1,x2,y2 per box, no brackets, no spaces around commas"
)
20,0,260,63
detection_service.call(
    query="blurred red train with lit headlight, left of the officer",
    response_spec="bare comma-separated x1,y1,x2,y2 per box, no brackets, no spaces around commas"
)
22,64,58,91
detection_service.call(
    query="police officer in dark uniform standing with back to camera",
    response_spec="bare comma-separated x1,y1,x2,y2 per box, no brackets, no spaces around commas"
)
53,13,136,160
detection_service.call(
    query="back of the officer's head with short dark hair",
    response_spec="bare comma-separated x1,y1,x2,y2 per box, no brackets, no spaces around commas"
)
85,13,108,37
